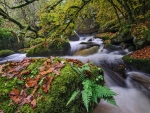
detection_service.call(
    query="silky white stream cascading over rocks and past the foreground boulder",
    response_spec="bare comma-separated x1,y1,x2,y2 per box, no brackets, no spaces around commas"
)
0,36,150,113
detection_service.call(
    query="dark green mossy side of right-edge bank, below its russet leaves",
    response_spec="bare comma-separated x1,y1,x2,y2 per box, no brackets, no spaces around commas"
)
123,55,150,74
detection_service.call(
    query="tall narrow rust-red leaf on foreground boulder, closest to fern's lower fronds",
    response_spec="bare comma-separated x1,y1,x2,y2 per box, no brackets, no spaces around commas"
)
42,76,54,93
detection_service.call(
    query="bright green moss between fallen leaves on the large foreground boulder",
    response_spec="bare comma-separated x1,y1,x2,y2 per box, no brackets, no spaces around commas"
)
0,58,103,113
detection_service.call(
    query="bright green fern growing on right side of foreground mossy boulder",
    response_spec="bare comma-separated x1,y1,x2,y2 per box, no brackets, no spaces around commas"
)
66,63,117,112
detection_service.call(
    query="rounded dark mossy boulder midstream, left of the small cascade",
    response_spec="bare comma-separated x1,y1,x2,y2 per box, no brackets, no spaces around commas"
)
27,38,70,57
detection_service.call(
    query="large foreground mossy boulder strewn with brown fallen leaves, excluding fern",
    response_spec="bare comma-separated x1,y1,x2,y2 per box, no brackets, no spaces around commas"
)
0,57,103,113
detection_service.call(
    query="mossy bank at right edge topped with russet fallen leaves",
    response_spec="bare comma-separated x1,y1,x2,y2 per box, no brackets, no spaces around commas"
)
123,46,150,74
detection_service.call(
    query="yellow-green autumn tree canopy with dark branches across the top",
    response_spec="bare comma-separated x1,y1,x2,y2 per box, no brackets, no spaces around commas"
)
0,0,150,38
